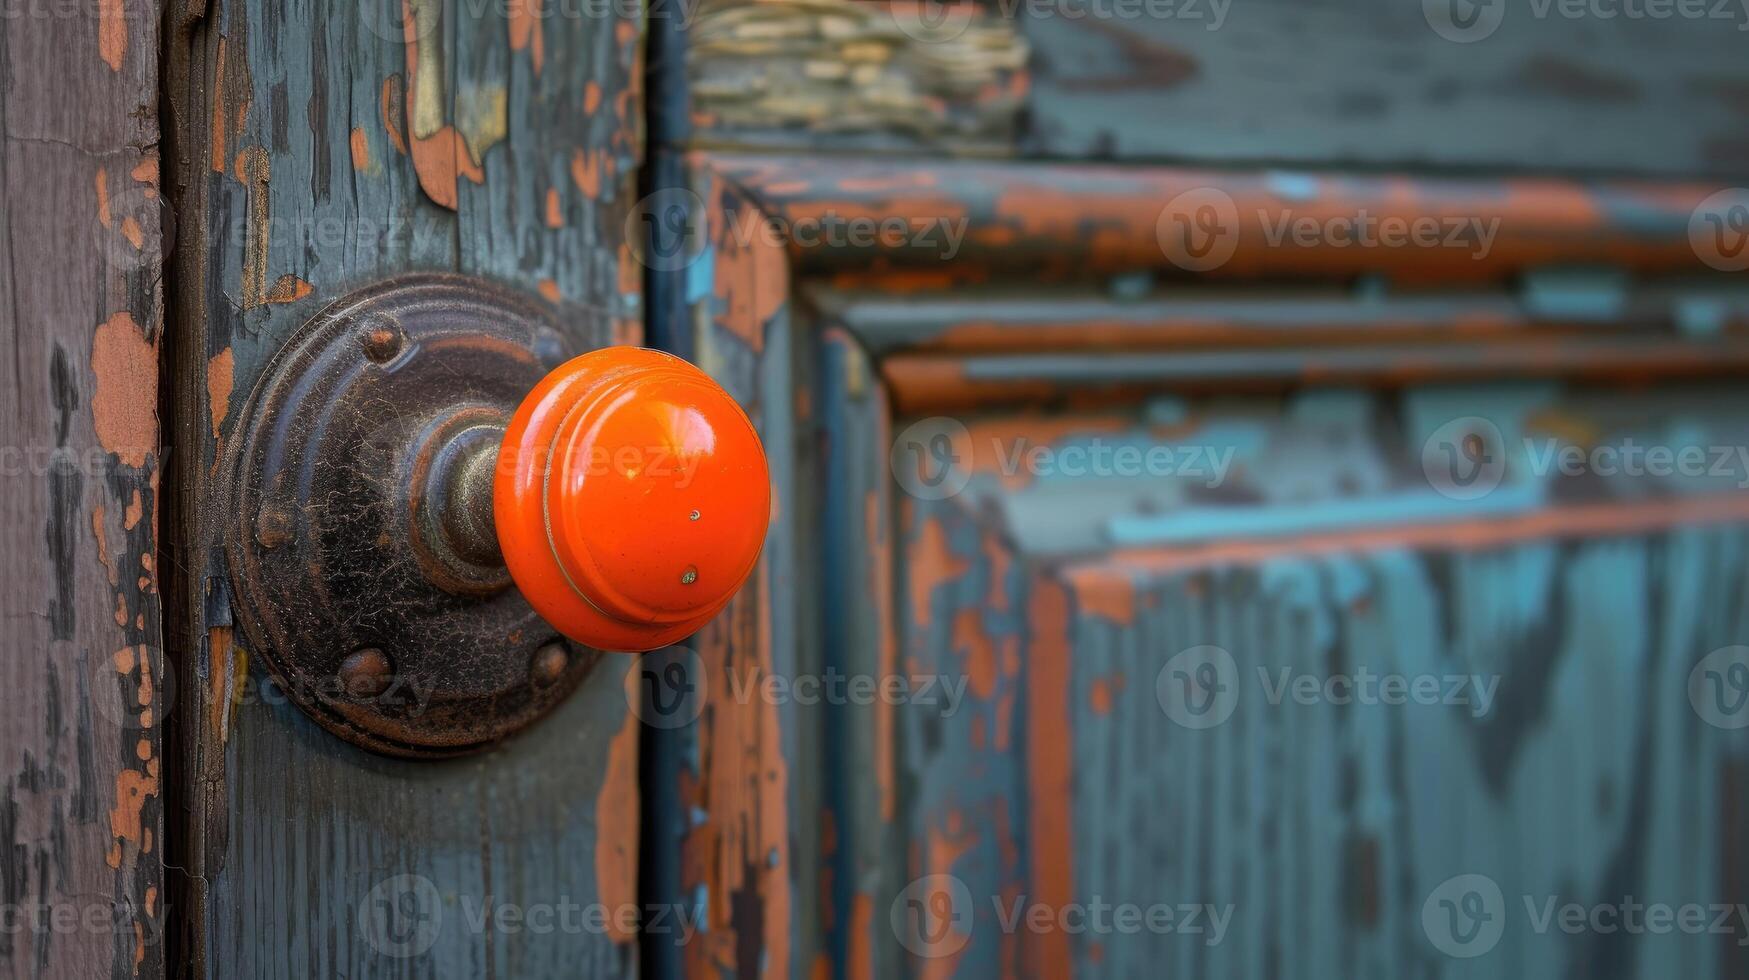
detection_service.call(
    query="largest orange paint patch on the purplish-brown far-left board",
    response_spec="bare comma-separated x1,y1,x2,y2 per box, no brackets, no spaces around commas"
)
91,312,157,467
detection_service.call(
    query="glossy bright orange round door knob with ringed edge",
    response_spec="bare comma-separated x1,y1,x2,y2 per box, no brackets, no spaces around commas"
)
493,347,771,651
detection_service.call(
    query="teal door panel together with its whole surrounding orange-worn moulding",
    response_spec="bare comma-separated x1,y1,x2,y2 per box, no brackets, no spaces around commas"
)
682,147,1749,978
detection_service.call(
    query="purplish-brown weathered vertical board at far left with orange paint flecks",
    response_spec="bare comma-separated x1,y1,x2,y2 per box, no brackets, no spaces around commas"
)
0,0,173,978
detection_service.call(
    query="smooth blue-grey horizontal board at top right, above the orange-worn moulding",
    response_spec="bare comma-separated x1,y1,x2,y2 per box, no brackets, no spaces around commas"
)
1009,0,1749,179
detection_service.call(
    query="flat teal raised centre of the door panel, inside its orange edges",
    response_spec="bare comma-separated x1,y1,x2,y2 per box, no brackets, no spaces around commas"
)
1070,527,1749,978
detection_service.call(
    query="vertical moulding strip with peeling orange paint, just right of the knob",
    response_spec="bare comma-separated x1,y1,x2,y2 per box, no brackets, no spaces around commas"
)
680,170,819,980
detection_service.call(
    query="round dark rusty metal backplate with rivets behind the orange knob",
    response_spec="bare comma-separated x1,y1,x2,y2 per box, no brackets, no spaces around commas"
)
226,275,598,756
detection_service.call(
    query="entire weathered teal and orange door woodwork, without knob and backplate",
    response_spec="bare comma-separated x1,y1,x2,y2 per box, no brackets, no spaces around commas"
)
10,0,1749,980
